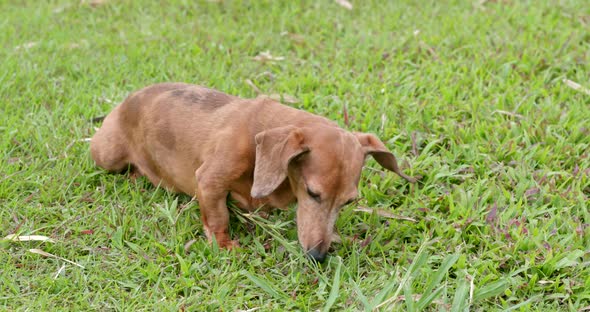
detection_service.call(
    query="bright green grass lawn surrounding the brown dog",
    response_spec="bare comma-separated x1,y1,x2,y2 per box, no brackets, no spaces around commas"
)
0,0,590,311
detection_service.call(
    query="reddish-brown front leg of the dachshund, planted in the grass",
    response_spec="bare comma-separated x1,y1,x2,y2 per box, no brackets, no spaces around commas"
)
195,164,239,249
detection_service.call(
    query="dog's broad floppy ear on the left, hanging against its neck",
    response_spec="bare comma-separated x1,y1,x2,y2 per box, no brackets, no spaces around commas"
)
250,126,309,198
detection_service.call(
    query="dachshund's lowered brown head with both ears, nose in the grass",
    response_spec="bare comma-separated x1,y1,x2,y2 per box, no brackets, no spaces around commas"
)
251,126,415,262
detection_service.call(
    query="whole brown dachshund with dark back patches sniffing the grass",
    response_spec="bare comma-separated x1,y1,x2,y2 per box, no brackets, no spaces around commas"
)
90,83,416,262
